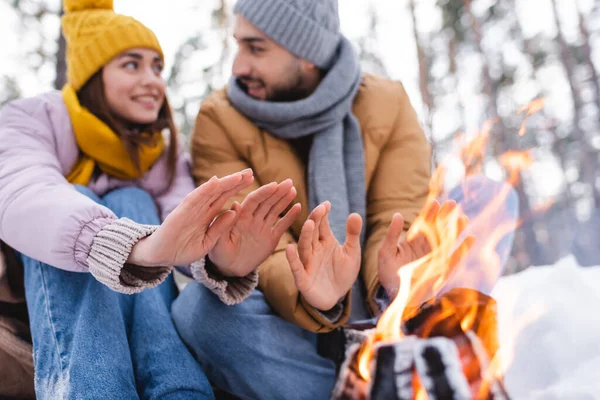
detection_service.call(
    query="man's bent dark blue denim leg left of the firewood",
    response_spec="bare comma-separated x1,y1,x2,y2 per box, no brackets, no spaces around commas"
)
172,282,335,400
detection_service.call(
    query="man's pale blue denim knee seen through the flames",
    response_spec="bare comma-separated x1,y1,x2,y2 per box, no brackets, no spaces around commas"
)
442,175,519,295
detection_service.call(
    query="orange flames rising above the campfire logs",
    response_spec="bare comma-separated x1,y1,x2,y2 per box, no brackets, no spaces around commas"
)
357,99,543,398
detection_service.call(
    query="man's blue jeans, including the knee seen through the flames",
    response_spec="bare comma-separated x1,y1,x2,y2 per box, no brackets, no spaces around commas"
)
172,177,518,400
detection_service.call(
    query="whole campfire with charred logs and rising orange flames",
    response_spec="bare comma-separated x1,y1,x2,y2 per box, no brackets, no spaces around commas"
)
323,113,539,400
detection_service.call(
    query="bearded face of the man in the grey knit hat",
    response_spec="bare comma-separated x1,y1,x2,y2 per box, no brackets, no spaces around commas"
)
232,15,316,102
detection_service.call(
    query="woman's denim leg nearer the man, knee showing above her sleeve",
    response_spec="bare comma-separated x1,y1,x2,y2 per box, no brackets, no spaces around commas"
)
103,188,214,399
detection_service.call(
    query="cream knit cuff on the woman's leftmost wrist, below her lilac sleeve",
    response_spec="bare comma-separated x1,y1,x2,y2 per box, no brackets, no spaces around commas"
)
87,218,172,294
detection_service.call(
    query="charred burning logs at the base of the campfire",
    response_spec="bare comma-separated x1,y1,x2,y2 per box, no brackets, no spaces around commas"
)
332,289,509,400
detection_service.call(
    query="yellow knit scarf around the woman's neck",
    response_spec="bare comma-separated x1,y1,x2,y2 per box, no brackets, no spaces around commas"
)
62,84,165,186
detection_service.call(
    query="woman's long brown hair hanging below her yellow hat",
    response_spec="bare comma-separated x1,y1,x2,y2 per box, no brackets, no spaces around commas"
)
77,70,178,186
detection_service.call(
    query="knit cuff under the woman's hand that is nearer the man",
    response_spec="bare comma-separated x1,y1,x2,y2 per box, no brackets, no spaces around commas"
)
190,258,258,306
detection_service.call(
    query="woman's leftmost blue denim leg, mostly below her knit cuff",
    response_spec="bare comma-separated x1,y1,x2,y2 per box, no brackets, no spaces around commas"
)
22,183,138,400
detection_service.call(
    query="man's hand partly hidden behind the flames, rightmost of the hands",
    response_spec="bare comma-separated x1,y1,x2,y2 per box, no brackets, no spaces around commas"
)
378,200,474,299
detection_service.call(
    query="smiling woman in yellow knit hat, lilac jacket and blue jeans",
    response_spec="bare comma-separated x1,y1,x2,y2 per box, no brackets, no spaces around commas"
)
0,0,299,399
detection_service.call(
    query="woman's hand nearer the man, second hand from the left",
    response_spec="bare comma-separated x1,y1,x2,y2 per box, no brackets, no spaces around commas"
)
208,179,300,276
